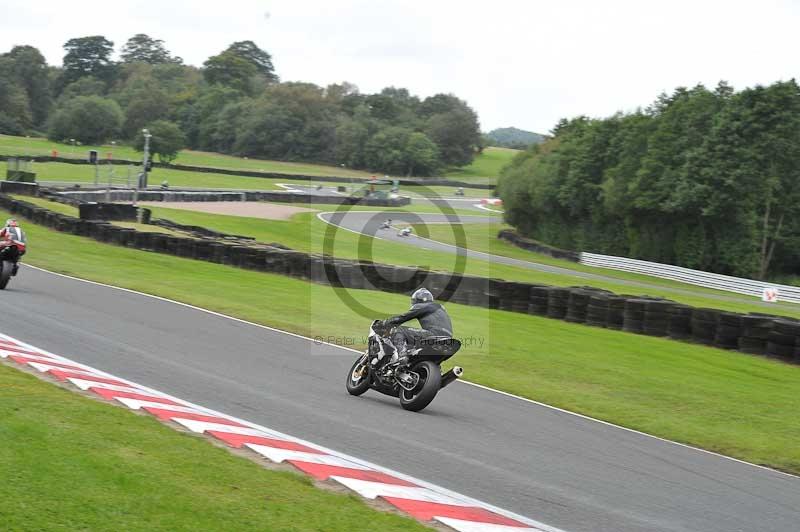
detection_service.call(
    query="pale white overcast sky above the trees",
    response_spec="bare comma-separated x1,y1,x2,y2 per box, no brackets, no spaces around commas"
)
0,0,800,133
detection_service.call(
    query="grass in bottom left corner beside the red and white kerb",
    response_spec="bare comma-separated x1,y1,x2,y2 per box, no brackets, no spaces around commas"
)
0,364,429,532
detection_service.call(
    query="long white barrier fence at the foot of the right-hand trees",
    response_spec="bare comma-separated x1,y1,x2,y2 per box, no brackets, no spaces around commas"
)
580,252,800,303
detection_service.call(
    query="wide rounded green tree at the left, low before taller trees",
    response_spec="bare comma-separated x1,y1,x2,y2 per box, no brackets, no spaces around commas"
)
47,96,122,144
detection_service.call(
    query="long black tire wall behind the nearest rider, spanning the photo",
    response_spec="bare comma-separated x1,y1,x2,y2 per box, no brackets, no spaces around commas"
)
0,194,800,364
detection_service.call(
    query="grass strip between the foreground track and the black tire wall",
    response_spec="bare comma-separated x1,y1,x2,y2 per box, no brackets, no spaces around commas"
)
6,208,800,474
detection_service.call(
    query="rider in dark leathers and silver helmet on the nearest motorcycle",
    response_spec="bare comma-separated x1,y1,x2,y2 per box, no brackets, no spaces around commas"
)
383,287,453,360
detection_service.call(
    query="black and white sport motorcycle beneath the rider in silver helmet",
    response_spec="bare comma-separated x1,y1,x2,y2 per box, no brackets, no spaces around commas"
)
346,320,464,412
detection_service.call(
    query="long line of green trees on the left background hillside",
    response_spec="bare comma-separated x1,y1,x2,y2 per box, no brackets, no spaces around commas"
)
0,34,482,176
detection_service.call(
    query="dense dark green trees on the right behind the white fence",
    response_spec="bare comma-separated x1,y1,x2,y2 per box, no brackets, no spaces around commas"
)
498,80,800,279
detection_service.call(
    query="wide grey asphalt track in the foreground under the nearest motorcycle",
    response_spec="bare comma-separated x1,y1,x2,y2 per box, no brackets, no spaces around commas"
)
6,267,800,532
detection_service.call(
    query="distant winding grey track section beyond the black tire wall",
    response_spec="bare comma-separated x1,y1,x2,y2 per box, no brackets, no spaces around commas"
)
319,208,792,308
